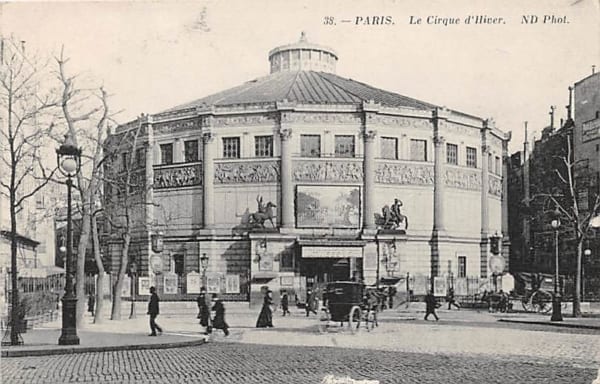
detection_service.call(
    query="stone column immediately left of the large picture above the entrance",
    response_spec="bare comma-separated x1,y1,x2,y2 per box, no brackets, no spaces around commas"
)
279,118,295,229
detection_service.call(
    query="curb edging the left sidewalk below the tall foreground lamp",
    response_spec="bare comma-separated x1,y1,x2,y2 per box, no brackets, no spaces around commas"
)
0,339,206,357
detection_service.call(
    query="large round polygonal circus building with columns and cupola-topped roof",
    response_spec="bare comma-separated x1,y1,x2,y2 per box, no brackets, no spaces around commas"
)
105,34,510,300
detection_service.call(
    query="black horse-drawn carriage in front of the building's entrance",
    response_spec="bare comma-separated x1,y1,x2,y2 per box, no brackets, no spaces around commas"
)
319,281,377,333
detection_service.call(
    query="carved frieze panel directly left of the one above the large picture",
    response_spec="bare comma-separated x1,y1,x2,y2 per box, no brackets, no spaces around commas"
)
215,161,279,184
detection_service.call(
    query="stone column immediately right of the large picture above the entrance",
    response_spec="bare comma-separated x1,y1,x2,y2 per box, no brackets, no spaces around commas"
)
363,123,377,230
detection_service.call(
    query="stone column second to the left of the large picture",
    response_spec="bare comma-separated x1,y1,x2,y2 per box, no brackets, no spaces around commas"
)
202,116,217,229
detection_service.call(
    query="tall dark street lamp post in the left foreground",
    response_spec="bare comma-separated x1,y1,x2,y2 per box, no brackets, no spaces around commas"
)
56,134,81,345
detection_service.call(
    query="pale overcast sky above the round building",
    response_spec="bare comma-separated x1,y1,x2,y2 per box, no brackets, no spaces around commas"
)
0,0,600,151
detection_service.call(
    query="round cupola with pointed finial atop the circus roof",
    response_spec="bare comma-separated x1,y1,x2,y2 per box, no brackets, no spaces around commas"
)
269,31,338,73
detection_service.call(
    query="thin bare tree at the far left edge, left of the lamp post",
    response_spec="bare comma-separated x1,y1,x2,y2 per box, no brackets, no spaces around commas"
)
0,38,57,345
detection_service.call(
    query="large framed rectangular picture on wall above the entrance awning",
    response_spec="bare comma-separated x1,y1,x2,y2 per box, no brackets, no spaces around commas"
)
296,185,360,228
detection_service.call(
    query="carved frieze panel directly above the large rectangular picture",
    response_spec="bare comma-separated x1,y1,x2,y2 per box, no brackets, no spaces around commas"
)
292,161,363,182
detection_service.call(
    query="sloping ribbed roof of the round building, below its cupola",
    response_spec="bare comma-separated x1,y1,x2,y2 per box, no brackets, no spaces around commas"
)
163,71,436,112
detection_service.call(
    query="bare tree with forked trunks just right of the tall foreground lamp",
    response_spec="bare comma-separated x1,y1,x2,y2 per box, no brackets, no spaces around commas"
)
56,49,111,324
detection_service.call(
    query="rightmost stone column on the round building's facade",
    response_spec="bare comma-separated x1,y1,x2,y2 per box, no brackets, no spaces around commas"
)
480,119,493,277
